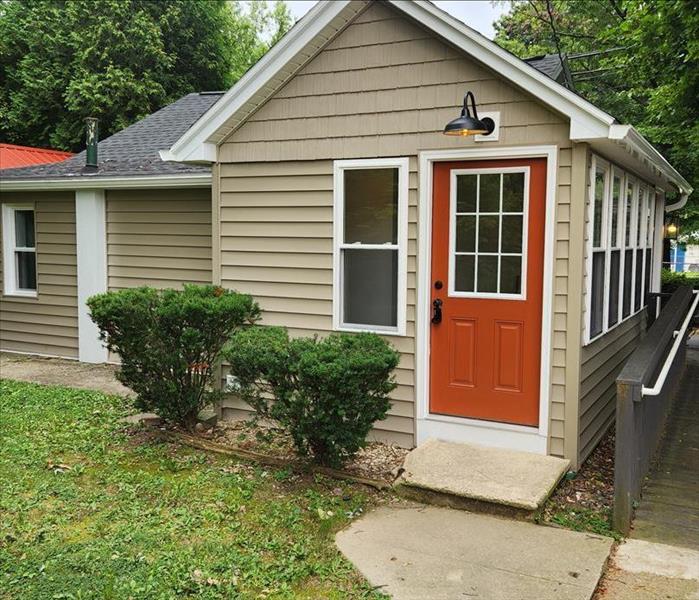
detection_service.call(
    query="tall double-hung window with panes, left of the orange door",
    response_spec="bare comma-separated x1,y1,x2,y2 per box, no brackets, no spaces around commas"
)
333,158,408,335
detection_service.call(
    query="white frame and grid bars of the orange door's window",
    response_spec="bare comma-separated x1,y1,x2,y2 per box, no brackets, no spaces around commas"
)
448,167,530,301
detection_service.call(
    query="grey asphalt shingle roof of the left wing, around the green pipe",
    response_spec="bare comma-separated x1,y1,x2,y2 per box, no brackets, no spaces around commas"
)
0,92,223,180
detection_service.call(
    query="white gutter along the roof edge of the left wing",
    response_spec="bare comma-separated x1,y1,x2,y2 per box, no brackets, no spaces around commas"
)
0,173,211,192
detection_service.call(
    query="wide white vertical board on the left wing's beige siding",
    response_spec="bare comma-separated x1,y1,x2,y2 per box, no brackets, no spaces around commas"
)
75,190,107,363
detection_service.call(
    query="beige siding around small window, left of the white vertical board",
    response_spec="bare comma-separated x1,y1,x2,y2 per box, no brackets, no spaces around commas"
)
0,192,78,356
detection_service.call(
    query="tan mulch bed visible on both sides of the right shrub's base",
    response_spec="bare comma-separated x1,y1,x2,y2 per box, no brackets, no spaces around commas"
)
197,421,409,483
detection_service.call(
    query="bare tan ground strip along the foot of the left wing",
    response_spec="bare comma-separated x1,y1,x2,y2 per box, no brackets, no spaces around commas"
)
0,352,133,396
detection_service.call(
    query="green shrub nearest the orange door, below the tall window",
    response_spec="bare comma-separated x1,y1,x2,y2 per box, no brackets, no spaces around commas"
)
224,327,399,467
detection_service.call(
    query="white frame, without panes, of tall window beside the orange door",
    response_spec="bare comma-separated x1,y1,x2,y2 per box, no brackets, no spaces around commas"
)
333,157,409,336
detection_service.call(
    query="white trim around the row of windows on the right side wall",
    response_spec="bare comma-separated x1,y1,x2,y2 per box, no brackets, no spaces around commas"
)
583,154,656,346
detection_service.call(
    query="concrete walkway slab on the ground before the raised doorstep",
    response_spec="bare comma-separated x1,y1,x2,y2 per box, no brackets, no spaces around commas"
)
336,505,612,600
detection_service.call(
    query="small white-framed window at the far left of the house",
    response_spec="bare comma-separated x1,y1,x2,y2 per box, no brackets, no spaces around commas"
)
2,204,36,296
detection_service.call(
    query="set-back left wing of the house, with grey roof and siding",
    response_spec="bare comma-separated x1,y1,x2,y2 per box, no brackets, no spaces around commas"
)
0,92,221,362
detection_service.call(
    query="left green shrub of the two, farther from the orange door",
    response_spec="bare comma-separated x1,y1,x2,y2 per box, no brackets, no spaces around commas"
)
87,285,259,428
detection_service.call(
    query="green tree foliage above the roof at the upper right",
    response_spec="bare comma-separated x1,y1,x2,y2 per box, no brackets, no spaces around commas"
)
495,0,699,233
